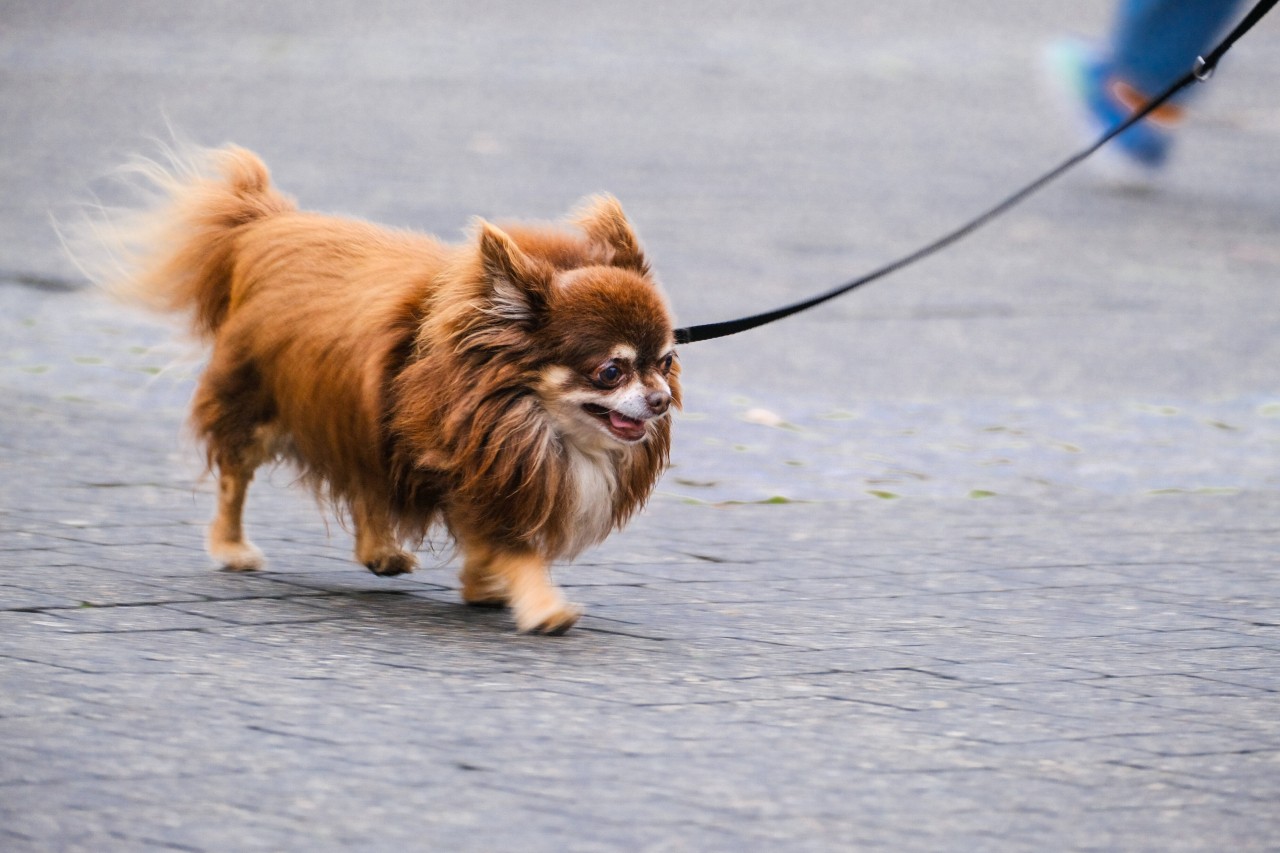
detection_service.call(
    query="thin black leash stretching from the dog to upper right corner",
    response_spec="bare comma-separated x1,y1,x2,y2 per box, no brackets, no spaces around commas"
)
676,0,1280,343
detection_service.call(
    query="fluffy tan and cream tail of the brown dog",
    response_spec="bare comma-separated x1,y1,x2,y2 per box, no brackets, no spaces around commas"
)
72,146,296,338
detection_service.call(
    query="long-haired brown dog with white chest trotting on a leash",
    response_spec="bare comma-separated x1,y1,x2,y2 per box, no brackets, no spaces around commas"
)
93,147,680,633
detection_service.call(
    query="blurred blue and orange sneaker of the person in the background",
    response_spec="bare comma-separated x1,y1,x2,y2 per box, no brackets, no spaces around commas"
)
1046,40,1183,178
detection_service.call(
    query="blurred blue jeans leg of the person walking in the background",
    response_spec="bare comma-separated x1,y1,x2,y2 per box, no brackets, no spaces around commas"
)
1110,0,1239,97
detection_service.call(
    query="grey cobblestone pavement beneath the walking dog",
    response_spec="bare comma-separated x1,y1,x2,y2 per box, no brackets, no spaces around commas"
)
0,0,1280,852
